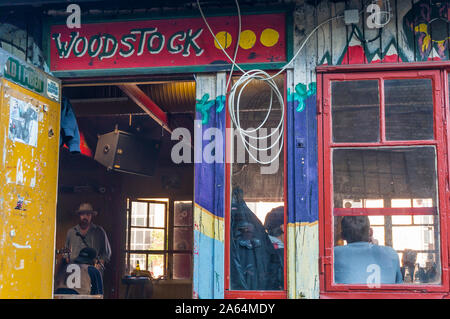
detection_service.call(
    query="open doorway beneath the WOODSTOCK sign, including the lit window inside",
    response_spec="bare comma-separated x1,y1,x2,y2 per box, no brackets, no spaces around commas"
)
55,76,196,299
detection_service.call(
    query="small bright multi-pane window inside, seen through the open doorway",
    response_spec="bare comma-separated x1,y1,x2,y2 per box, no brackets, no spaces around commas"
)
126,198,193,280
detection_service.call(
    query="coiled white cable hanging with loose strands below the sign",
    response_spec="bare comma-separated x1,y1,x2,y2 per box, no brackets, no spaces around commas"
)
196,0,343,165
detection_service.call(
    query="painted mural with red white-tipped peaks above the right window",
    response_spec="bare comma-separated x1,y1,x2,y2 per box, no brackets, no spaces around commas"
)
313,0,450,65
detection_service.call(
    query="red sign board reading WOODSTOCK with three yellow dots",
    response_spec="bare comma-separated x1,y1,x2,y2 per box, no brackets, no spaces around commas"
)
50,13,286,72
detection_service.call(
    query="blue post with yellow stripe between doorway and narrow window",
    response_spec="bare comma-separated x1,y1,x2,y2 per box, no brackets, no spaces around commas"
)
193,73,225,299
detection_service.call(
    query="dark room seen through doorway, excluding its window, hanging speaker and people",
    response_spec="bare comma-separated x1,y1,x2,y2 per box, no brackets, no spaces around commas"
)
56,80,195,298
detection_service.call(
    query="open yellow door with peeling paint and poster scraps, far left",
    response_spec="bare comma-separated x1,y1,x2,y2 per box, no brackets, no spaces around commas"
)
0,79,60,298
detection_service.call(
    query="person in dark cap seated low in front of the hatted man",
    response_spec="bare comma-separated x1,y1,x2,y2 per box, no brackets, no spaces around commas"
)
55,247,103,295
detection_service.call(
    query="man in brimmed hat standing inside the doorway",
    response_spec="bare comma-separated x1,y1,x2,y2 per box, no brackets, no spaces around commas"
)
66,203,111,275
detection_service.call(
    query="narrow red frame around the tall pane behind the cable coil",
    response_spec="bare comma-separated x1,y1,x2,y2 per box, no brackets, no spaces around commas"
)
224,72,288,299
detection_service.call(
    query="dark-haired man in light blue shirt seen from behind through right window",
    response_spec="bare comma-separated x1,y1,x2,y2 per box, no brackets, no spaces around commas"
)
334,216,403,284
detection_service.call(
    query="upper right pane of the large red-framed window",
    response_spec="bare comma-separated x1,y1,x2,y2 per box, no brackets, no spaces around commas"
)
384,79,434,140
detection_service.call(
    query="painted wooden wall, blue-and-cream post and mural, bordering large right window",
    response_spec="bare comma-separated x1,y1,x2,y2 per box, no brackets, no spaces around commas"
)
288,0,450,298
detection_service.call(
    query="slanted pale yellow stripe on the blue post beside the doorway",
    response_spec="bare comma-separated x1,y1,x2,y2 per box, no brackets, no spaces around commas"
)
194,204,225,242
